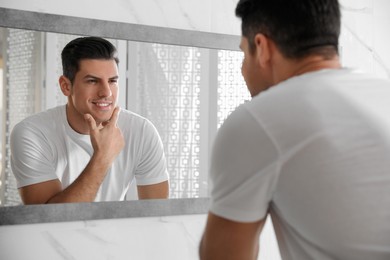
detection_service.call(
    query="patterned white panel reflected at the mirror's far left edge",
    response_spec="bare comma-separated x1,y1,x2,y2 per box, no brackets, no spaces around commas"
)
2,29,42,205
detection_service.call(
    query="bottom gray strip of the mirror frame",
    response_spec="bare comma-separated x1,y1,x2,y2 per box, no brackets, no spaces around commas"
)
0,198,210,226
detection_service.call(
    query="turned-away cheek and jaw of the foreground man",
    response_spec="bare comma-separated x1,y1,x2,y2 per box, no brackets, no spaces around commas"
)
240,36,271,97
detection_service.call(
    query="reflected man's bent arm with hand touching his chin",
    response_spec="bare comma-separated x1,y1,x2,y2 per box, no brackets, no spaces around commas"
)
19,108,124,204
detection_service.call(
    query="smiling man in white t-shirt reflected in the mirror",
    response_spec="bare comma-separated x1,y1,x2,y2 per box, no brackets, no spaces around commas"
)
11,37,168,204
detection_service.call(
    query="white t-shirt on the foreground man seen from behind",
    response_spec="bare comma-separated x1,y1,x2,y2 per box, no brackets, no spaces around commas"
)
210,69,390,260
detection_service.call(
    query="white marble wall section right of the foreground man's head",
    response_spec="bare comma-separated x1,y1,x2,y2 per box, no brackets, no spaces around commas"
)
340,0,390,78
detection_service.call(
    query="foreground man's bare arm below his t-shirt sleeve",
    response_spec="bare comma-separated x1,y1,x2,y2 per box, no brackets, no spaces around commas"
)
199,212,266,260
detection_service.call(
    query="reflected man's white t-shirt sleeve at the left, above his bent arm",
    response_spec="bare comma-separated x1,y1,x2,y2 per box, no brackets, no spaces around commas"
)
10,122,58,188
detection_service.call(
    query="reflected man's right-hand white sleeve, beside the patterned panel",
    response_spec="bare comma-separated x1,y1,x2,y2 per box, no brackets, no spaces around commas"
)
135,120,169,185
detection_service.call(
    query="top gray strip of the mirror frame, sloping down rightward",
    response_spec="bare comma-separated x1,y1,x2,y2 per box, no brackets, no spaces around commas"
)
0,8,241,51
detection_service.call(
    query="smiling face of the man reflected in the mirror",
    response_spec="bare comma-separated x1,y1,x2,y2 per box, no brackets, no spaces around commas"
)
67,59,119,129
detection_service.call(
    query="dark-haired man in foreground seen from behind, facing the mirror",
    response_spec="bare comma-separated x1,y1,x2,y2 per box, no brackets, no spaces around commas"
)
200,0,390,260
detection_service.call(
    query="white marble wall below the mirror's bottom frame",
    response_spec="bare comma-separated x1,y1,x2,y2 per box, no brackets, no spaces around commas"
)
0,214,280,260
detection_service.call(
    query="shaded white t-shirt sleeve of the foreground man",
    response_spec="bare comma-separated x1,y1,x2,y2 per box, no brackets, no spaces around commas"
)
210,107,278,222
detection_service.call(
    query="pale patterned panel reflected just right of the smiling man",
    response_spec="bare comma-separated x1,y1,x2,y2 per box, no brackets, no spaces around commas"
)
136,44,201,198
